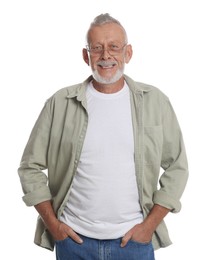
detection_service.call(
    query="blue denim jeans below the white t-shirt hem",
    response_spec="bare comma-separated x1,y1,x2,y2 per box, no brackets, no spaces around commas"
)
56,235,155,260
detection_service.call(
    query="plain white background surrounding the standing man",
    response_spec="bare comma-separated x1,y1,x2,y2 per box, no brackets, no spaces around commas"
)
0,0,209,260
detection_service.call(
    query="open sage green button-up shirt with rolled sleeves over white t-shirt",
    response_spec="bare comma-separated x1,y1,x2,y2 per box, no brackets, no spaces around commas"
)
18,75,188,250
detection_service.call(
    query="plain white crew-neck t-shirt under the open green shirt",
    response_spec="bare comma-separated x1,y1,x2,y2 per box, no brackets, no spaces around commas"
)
60,83,143,239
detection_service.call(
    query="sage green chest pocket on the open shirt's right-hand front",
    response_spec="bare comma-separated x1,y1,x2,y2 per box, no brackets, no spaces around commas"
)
144,125,163,165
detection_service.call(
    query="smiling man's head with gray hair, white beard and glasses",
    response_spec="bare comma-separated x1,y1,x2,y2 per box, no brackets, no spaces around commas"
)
83,14,132,88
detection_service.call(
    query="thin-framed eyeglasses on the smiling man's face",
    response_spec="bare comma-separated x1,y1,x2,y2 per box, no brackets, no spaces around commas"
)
86,43,127,56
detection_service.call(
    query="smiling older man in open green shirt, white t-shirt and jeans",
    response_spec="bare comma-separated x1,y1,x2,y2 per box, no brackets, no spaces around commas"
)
18,14,188,260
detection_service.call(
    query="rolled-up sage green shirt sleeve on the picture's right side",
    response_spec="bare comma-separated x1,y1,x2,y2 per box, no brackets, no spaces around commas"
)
153,100,188,212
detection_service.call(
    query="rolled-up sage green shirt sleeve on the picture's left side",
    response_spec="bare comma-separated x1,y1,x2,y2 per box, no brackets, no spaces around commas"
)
18,98,52,206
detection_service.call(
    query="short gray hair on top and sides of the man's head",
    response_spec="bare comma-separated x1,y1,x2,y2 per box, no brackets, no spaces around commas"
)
86,13,128,43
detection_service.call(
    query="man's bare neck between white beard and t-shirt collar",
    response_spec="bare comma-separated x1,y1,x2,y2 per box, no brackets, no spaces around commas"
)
92,77,124,94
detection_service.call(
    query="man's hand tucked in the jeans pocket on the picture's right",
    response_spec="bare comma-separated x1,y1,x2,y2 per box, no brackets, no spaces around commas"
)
121,223,153,247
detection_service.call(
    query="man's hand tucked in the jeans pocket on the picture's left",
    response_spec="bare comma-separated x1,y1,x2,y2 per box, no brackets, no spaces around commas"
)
51,221,83,244
